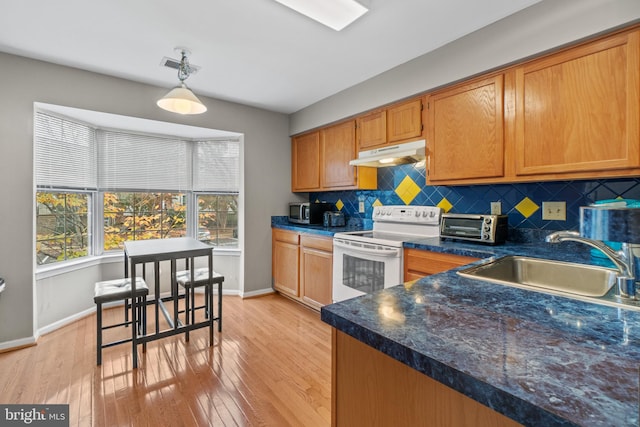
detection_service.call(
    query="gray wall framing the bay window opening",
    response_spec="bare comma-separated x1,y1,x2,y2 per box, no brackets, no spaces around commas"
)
0,53,292,348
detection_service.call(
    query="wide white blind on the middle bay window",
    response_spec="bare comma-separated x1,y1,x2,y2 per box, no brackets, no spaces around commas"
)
97,130,191,192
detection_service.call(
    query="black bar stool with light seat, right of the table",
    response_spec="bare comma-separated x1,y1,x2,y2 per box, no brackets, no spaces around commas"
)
176,264,224,341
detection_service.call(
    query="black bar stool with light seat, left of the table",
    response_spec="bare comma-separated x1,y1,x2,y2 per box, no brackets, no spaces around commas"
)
93,277,149,365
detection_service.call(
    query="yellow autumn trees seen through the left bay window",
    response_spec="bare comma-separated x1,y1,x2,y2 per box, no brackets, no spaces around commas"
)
36,191,91,265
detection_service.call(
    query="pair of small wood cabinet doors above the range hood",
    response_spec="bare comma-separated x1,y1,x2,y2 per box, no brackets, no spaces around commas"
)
356,98,422,151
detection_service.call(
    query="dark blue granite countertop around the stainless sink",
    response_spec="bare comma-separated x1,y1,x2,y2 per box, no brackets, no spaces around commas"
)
321,238,640,426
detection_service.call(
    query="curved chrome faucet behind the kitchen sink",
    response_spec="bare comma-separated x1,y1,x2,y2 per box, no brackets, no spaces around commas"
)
545,231,638,299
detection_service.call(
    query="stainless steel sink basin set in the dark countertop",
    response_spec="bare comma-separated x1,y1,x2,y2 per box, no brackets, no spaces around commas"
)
458,256,618,297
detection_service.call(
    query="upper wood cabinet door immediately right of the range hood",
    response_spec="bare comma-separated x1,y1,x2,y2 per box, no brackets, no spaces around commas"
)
427,75,504,182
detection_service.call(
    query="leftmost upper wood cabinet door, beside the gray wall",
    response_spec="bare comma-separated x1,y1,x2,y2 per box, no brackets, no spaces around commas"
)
291,132,320,191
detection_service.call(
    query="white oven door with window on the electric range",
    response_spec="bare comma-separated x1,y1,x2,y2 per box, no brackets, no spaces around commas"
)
332,238,402,302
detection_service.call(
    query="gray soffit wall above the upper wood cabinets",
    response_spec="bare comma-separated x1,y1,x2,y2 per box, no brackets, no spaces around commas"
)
290,0,640,135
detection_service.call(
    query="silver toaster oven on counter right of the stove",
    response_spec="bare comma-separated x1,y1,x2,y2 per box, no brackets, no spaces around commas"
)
440,213,509,245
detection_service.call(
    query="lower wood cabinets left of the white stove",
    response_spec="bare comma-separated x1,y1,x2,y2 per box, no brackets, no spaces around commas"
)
271,228,333,310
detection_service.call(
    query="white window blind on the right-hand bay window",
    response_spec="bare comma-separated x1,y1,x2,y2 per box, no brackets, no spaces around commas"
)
193,141,240,193
